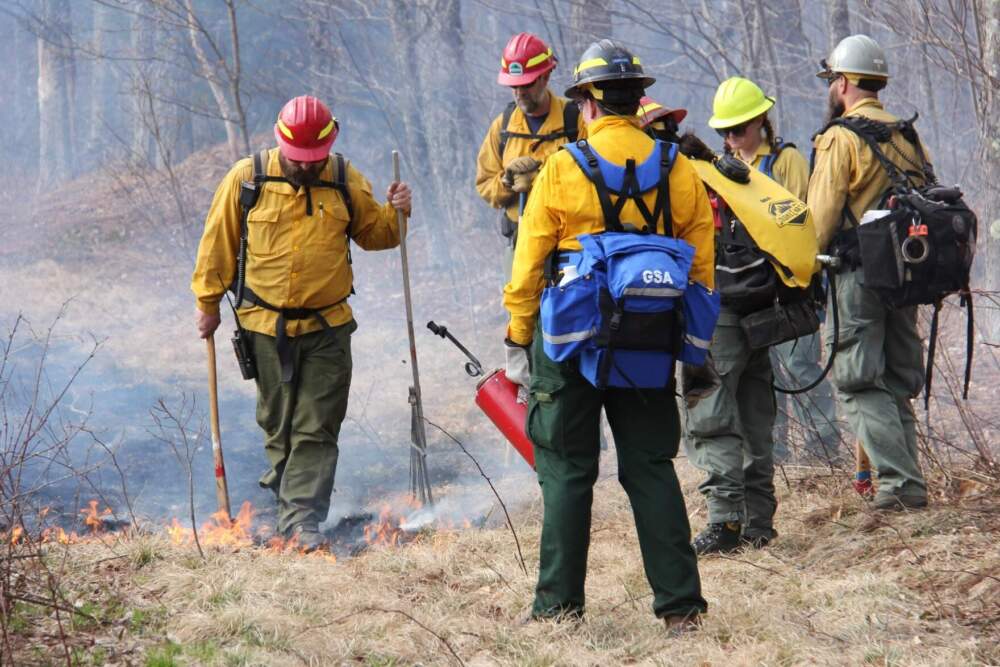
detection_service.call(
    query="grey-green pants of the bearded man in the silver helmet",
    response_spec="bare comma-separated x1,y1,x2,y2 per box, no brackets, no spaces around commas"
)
824,271,927,497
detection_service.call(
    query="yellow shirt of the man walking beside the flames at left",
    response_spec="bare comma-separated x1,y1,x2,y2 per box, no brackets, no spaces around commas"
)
191,148,399,336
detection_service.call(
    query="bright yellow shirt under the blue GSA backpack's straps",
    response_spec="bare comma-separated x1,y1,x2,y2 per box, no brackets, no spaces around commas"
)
504,116,715,345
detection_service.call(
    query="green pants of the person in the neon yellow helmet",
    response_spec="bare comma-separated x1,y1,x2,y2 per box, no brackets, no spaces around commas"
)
687,309,778,537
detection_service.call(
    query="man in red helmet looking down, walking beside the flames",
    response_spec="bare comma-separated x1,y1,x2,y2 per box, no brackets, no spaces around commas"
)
191,96,411,549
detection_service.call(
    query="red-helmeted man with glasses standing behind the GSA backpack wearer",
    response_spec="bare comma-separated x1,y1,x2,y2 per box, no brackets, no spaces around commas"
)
476,32,583,280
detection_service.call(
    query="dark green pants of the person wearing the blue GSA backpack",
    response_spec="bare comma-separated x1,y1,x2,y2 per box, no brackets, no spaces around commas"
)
528,330,707,617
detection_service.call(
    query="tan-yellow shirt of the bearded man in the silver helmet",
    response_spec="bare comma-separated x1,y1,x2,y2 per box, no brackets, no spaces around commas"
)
808,98,930,252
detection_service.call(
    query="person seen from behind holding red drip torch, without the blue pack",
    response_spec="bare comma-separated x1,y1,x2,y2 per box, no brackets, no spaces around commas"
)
504,39,714,630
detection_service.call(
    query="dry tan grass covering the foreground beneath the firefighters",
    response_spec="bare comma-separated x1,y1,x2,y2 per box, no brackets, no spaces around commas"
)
15,461,1000,665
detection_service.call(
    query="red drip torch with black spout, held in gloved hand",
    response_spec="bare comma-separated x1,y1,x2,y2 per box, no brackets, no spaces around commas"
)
427,322,535,468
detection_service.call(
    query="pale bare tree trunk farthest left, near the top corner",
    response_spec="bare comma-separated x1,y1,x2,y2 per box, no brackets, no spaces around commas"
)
38,0,73,191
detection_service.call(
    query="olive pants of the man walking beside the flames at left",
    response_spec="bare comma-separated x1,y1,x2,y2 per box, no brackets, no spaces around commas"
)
253,320,357,534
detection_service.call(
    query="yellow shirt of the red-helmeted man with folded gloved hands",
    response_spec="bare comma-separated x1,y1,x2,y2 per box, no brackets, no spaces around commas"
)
476,91,586,221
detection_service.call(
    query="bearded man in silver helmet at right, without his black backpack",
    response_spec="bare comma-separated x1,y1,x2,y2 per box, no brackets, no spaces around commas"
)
809,35,933,510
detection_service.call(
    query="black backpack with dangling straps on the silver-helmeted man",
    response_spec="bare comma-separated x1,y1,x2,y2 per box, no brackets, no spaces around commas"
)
824,116,978,408
